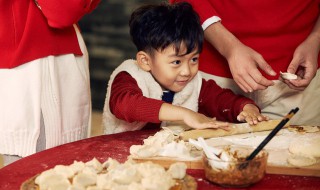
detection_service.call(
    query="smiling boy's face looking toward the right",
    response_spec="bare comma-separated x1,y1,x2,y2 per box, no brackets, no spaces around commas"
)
149,45,199,92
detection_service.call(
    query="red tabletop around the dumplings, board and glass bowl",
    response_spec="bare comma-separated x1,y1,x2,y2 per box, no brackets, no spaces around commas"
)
0,130,320,190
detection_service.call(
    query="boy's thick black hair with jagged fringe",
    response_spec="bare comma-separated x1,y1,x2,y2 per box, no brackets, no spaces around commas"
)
129,2,203,55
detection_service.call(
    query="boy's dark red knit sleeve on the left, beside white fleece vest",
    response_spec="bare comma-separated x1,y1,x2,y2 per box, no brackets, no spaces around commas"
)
109,72,164,123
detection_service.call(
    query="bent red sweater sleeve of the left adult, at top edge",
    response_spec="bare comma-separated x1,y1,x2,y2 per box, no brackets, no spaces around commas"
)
35,0,101,28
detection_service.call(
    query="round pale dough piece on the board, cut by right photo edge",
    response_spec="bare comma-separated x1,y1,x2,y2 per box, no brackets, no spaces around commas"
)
289,134,320,157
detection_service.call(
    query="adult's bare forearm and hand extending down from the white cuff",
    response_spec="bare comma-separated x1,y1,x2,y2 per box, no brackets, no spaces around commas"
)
204,22,276,92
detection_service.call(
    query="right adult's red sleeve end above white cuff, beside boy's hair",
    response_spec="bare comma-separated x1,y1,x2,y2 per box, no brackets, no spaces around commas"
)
170,0,219,24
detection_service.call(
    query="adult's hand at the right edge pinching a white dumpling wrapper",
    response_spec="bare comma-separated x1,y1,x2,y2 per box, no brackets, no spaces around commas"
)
284,18,320,90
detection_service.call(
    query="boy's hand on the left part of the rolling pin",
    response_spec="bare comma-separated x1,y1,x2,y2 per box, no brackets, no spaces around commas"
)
183,111,229,130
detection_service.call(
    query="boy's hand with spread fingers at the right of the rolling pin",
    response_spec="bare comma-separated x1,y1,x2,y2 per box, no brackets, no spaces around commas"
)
237,104,269,125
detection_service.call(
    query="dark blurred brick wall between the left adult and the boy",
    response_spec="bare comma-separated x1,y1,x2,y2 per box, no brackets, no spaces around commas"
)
79,0,164,111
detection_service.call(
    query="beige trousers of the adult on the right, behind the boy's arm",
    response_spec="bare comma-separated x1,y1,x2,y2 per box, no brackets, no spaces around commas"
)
201,70,320,126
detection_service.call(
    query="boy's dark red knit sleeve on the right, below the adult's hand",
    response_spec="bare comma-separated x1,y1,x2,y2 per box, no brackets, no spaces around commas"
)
199,79,258,122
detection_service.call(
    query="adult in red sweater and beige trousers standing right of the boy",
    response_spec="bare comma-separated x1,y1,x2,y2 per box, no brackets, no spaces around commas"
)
171,0,320,125
